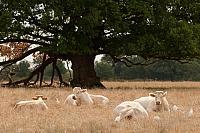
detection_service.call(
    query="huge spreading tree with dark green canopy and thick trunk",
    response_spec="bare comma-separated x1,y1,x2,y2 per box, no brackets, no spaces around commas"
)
0,0,200,87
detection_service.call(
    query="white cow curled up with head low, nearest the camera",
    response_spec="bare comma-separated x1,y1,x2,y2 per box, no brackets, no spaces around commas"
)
113,101,149,122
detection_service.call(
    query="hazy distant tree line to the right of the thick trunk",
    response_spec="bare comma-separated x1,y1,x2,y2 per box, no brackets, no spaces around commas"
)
95,57,200,81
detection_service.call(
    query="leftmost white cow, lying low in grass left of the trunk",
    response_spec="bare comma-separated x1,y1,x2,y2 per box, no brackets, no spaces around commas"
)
14,95,48,109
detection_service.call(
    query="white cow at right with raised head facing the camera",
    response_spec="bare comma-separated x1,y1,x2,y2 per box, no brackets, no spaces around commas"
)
134,91,170,112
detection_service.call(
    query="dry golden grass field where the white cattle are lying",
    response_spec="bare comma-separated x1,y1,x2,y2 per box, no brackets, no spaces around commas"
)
0,82,200,133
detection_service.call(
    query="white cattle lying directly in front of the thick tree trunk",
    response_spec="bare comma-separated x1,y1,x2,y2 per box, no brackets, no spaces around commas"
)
65,87,109,106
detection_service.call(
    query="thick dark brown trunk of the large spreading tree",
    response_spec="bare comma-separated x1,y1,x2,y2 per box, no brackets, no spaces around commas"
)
71,55,105,88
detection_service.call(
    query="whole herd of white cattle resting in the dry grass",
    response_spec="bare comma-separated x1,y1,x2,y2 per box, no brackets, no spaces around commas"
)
14,87,193,122
